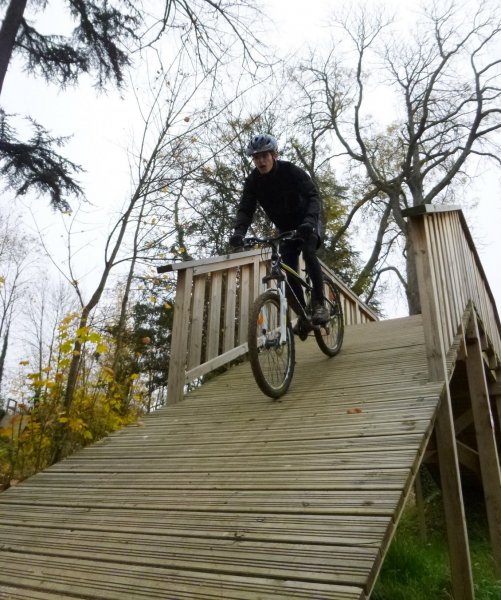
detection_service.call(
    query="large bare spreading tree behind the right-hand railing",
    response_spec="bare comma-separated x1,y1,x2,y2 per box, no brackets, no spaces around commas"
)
292,1,501,314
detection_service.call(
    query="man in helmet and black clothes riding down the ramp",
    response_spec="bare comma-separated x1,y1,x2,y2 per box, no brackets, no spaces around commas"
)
229,134,329,339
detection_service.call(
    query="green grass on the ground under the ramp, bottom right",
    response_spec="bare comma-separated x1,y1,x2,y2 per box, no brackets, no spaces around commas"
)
371,490,501,600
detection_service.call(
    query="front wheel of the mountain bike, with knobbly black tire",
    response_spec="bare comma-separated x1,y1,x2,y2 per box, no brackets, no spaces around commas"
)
247,290,295,398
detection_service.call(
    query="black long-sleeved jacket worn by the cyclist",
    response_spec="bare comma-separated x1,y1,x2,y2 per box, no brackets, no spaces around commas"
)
234,160,323,238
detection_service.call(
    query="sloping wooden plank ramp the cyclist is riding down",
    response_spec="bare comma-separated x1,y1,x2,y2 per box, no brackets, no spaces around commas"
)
0,317,442,600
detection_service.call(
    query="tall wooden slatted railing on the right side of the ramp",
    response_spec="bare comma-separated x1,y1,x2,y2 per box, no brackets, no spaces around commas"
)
405,205,501,379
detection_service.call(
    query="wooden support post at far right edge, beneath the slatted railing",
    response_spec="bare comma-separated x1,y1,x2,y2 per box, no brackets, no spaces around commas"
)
466,312,501,575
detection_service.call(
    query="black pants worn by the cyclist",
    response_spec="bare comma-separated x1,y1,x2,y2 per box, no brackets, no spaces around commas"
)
281,234,324,313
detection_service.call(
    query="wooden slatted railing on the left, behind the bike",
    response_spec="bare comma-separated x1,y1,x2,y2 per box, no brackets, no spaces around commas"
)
158,250,378,404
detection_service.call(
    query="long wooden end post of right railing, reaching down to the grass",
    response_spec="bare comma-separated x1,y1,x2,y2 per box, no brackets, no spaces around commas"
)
407,212,475,600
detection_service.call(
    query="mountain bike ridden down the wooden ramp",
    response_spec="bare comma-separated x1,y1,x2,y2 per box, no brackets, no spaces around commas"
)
243,231,344,398
